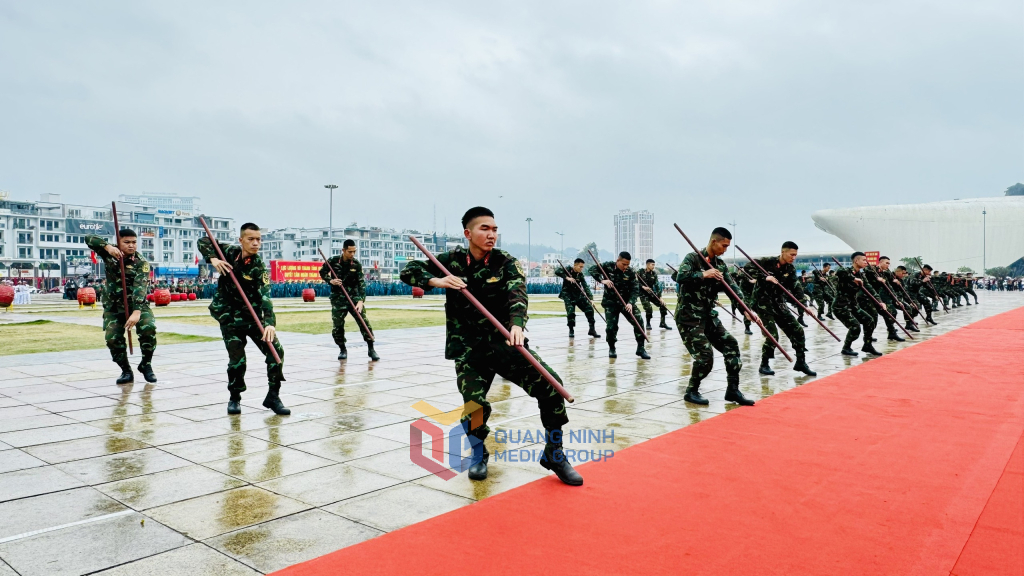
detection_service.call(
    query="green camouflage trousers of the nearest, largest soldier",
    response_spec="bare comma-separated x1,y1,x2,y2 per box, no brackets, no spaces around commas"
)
455,342,569,440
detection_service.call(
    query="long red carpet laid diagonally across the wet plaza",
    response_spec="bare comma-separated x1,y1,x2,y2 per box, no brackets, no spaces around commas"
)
278,308,1024,576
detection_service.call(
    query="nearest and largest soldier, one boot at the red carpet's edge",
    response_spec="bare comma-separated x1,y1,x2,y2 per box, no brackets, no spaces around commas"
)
401,206,583,486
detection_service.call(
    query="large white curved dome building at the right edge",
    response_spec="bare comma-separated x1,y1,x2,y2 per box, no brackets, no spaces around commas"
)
811,196,1024,272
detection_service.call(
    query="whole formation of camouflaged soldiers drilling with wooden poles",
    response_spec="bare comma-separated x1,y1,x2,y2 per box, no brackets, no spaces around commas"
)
86,207,1007,486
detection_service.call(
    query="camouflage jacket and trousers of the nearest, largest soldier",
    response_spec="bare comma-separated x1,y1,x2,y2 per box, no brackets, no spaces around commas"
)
401,242,568,448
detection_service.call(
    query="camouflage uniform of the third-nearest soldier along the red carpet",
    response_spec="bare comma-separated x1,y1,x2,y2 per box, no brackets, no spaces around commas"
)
743,256,807,363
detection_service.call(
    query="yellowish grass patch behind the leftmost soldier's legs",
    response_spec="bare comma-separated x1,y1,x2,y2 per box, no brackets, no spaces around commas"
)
0,320,217,356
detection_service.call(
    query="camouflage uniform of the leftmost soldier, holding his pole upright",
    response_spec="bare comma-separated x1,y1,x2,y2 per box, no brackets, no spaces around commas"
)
85,235,157,364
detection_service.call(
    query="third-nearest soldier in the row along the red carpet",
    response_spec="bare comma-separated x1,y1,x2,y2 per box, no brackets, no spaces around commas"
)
743,242,817,376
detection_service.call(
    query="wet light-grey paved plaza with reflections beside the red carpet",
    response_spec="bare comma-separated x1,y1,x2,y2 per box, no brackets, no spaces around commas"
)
0,292,1024,576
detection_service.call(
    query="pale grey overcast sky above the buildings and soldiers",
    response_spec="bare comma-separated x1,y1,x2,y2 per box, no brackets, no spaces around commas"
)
0,0,1024,254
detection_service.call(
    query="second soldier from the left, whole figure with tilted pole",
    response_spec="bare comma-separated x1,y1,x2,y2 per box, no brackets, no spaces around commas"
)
196,222,292,416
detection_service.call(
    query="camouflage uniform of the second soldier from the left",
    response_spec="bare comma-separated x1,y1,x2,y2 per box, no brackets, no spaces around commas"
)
196,237,285,395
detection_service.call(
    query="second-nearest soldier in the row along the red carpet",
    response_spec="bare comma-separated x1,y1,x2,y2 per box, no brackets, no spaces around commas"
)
672,228,754,406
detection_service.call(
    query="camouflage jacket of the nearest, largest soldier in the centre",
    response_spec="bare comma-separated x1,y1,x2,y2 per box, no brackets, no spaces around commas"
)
401,246,527,360
